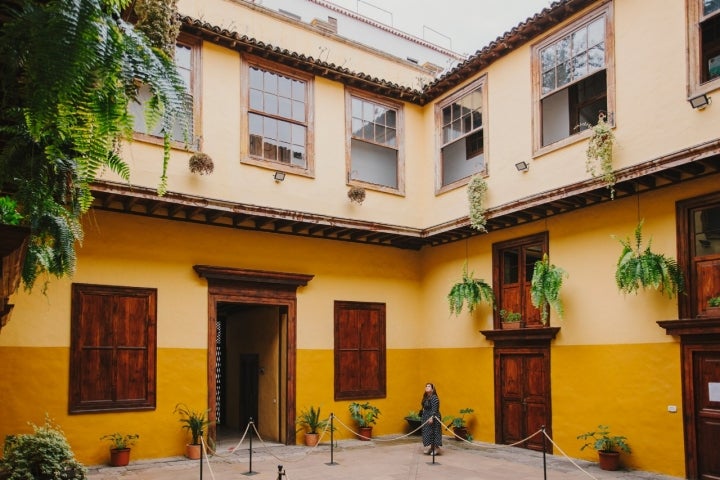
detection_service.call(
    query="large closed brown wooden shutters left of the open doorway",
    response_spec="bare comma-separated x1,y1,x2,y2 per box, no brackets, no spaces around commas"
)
69,284,157,413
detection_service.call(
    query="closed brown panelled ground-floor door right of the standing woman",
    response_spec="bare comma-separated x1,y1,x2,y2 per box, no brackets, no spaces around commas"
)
495,347,551,451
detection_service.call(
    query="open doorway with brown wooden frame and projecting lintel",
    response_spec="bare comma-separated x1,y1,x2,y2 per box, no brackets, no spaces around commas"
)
193,265,314,445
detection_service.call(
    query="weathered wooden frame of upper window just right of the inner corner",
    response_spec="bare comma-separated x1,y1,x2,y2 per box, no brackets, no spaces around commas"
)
435,75,489,195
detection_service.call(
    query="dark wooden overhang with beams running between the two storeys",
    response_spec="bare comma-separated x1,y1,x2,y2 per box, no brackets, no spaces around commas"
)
93,153,720,250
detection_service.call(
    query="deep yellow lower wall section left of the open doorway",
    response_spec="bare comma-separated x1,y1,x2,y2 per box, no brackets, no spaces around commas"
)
0,347,207,465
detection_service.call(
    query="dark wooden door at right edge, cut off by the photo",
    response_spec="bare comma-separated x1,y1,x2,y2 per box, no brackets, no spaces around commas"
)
693,350,720,480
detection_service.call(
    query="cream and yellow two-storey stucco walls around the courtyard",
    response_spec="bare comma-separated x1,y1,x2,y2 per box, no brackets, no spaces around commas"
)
0,0,720,476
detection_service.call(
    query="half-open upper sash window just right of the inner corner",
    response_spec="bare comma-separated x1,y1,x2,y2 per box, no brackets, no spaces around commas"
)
436,77,487,190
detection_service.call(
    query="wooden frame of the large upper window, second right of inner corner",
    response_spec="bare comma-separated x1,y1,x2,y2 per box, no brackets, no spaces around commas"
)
532,0,615,157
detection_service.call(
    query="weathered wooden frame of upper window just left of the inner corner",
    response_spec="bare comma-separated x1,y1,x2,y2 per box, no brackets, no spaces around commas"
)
345,87,405,195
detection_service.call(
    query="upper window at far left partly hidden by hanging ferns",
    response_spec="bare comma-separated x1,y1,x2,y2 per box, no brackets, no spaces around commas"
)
130,36,200,148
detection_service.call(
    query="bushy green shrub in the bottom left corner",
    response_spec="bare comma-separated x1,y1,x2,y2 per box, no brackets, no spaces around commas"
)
0,415,87,480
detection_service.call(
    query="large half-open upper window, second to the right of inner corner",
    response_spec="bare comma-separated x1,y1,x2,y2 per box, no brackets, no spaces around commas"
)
533,4,614,150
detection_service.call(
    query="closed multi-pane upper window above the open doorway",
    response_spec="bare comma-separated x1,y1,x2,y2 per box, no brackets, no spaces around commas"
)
248,65,310,171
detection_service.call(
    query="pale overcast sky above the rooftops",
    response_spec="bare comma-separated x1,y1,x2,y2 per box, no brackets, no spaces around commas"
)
327,0,551,54
